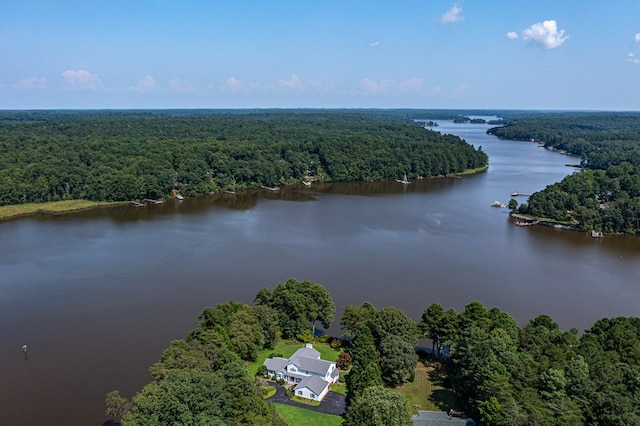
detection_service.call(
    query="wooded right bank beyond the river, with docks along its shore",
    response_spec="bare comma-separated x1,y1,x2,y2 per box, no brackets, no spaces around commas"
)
488,113,640,235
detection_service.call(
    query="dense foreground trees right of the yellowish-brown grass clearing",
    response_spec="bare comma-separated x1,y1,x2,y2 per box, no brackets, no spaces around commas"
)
420,302,640,425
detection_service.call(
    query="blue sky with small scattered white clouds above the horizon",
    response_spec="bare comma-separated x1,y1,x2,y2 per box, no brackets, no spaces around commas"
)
0,0,640,111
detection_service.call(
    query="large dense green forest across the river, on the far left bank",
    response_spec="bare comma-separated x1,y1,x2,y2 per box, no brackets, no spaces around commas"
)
0,110,488,205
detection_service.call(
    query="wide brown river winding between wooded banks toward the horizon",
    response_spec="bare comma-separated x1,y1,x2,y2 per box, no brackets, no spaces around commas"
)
0,123,640,425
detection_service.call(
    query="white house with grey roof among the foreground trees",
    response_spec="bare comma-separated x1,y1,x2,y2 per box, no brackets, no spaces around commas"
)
264,343,339,401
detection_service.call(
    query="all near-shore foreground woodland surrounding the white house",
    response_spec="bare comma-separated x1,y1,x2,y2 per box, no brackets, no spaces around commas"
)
106,279,640,426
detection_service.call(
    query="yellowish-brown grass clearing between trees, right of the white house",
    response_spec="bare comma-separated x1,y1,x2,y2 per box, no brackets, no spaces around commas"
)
395,362,460,413
